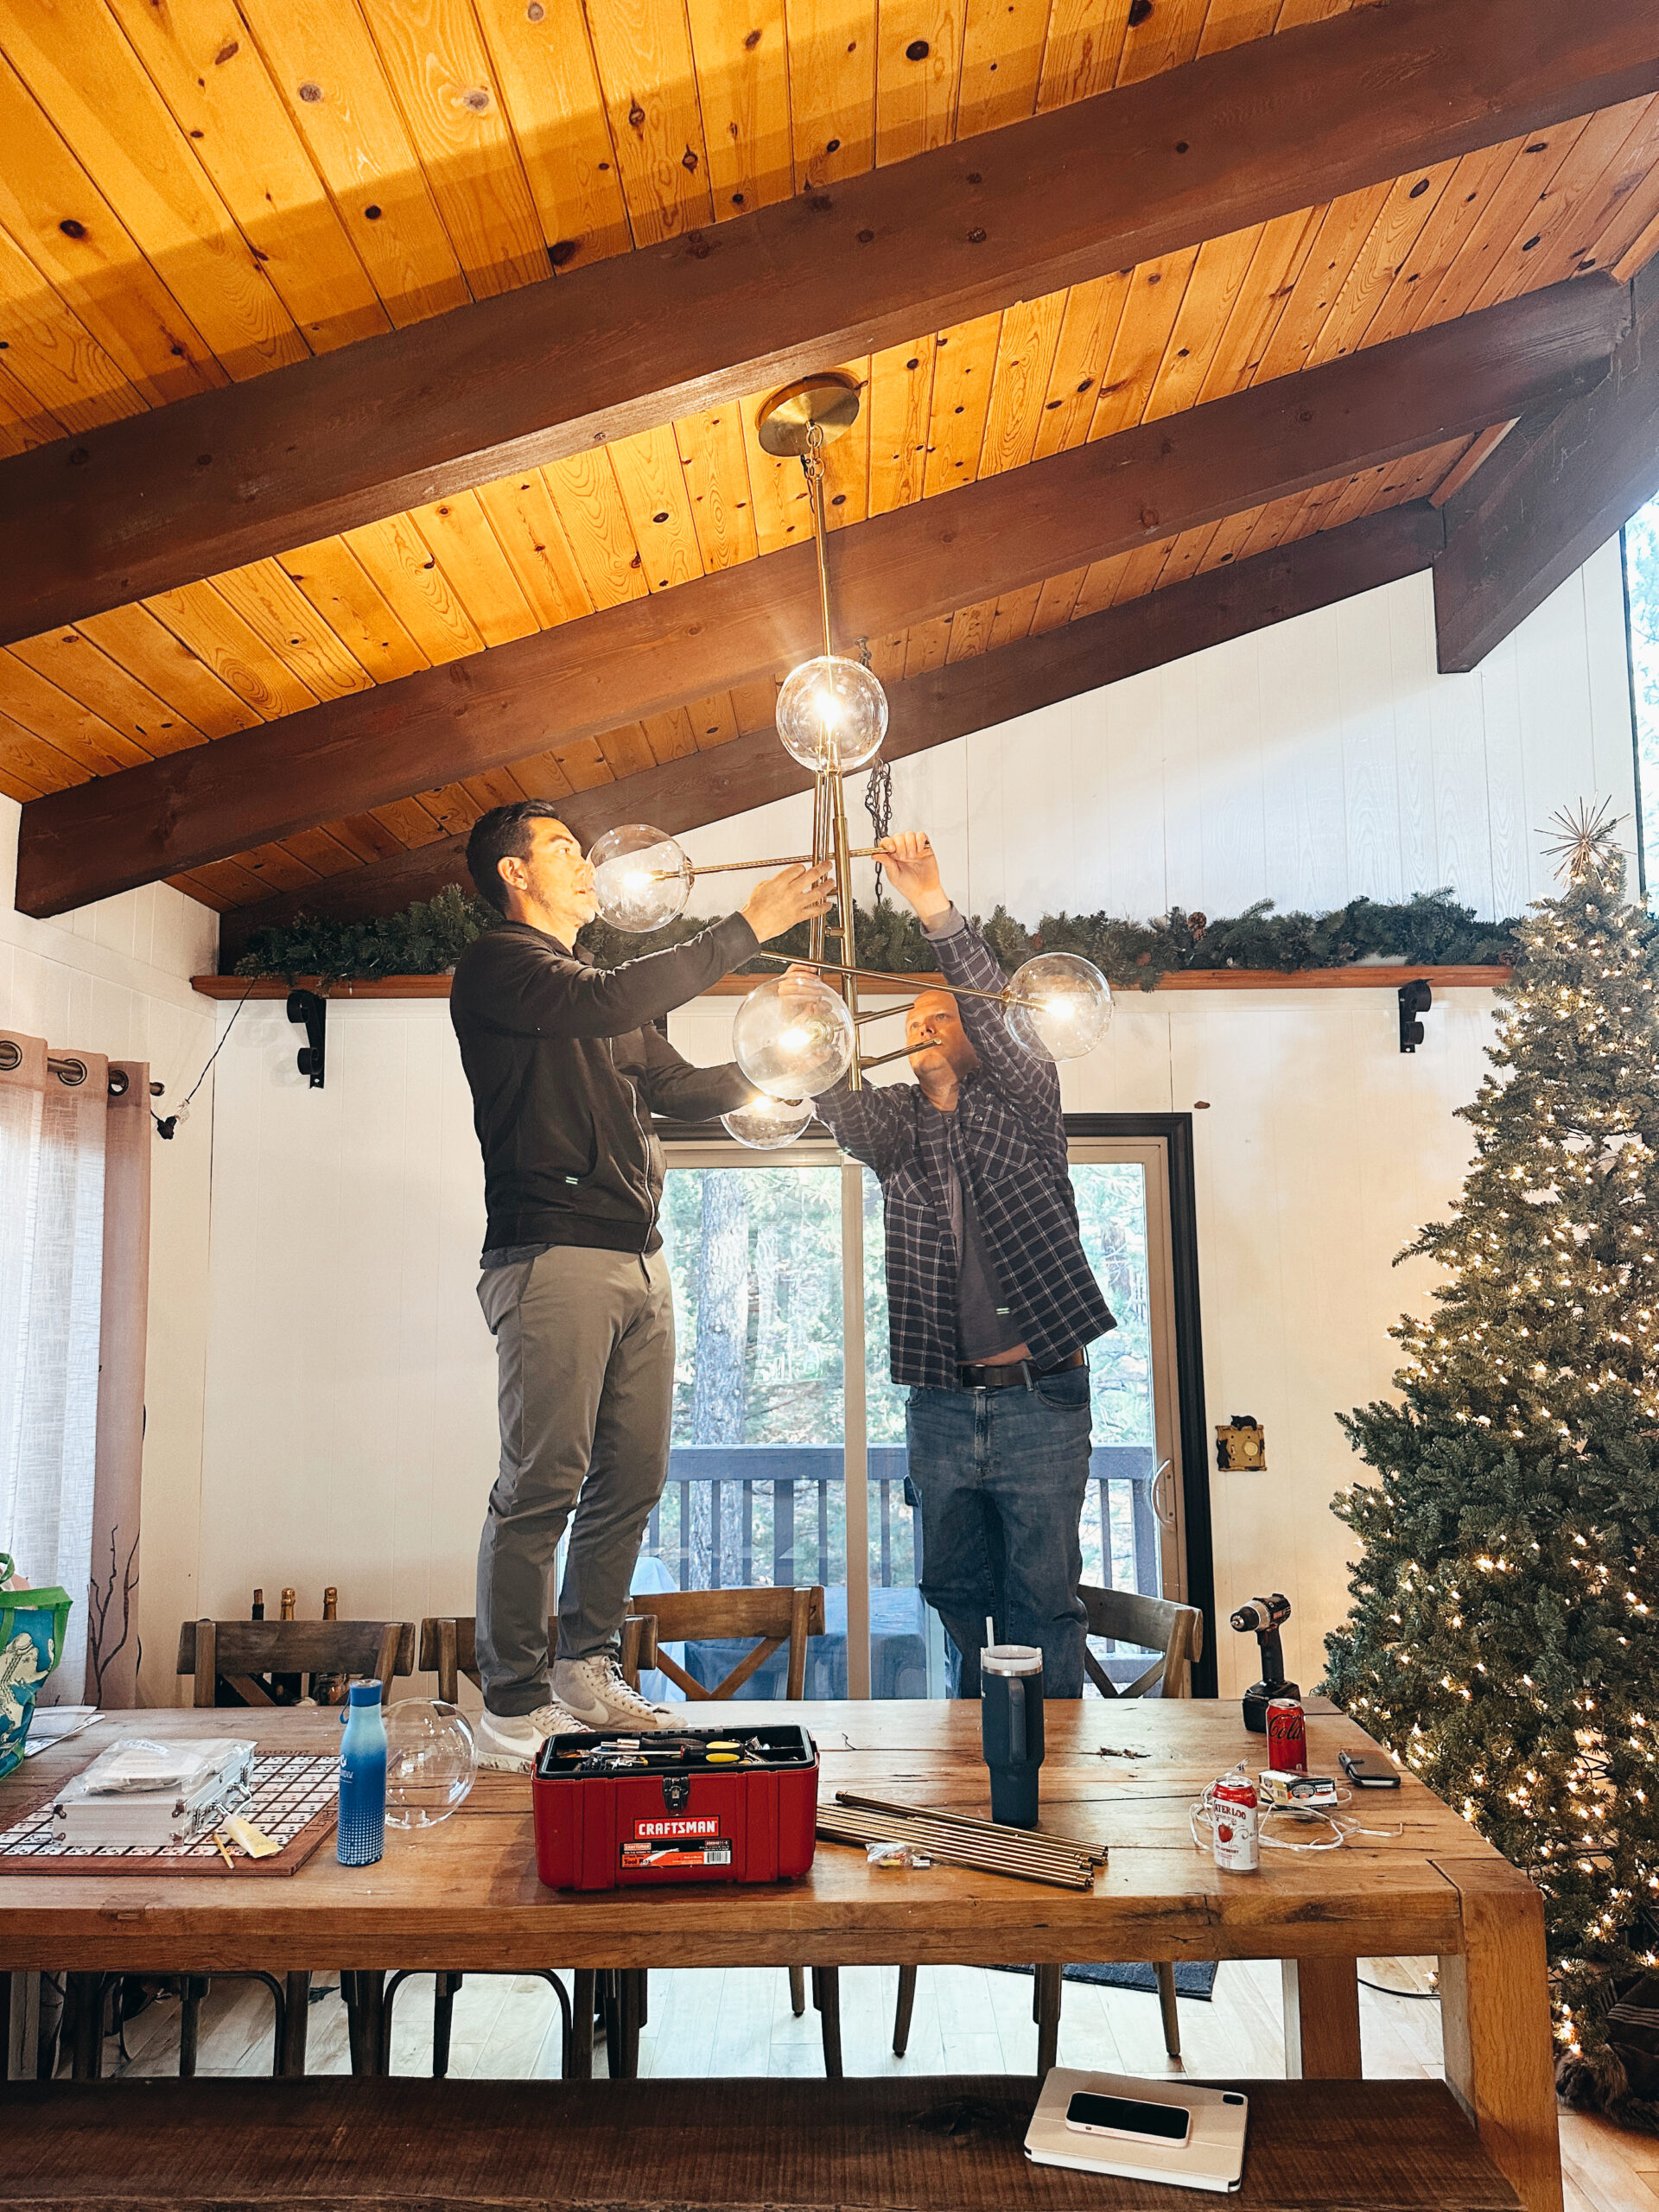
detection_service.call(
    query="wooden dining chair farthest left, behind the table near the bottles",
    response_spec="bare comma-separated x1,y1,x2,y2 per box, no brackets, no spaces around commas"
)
156,1619,414,2077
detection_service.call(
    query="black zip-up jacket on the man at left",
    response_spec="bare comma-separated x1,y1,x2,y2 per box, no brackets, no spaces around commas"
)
449,913,759,1252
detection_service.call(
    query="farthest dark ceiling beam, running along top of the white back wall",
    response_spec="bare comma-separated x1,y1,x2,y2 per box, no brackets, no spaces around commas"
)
219,500,1445,967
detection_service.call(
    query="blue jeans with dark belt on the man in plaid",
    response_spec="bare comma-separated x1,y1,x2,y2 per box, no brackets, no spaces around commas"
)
905,1367,1089,1697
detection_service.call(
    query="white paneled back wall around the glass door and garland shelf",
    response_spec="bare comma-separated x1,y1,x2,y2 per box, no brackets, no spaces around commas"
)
191,549,1632,1688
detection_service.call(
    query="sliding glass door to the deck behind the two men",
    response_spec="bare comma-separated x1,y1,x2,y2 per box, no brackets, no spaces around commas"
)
650,1135,1211,1697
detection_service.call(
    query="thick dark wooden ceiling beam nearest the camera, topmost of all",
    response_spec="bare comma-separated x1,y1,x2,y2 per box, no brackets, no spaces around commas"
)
0,0,1659,641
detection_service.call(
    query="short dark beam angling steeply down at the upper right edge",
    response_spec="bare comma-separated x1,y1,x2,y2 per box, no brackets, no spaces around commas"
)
1433,261,1659,675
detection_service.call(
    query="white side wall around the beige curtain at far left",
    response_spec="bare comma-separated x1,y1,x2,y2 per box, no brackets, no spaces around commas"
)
0,794,219,1703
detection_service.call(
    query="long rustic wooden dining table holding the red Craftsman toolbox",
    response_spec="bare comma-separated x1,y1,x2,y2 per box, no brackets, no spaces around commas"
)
0,1699,1561,2212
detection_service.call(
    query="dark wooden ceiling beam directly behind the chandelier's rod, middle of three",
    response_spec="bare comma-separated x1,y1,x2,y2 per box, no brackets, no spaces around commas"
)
17,276,1630,913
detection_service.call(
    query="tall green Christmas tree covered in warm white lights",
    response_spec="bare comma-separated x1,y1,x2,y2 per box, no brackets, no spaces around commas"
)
1325,810,1659,2124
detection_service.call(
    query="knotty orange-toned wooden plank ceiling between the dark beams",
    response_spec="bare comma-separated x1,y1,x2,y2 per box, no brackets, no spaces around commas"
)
0,0,1659,907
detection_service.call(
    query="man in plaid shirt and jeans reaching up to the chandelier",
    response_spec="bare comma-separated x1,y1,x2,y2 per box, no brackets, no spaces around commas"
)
817,832,1115,1697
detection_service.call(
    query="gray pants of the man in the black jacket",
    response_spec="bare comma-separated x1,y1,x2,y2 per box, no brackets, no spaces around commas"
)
478,1245,675,1717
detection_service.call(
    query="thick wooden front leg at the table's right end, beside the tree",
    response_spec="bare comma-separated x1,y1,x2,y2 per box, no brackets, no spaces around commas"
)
1435,1858,1561,2212
